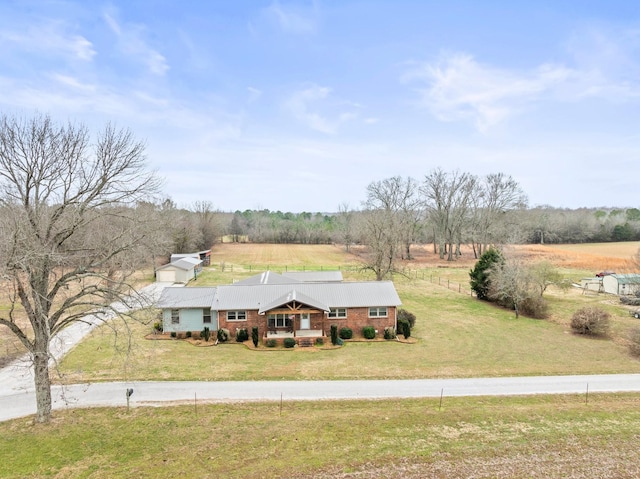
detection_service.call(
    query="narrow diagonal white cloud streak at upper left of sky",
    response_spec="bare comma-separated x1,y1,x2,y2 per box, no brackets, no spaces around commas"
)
103,12,169,76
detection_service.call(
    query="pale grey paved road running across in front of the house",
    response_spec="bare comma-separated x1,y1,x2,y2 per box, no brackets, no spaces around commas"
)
0,374,640,421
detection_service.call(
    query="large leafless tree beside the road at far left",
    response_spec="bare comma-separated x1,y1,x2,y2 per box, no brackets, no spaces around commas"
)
0,116,159,422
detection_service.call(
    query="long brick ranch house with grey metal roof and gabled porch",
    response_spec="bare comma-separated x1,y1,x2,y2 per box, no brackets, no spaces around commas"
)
156,271,401,339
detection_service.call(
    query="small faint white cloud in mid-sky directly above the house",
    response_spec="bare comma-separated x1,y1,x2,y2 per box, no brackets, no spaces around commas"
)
285,84,357,134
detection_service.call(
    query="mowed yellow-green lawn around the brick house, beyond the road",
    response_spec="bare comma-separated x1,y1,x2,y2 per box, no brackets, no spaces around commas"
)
57,269,640,382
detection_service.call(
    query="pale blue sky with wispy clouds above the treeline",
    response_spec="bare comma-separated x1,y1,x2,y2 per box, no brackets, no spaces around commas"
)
0,0,640,212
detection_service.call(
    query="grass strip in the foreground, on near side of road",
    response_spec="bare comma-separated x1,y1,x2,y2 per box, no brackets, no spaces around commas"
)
0,394,640,479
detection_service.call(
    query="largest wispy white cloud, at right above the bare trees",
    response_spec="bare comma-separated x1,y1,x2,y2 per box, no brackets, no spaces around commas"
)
404,53,573,132
